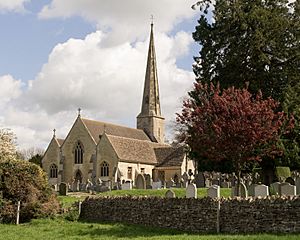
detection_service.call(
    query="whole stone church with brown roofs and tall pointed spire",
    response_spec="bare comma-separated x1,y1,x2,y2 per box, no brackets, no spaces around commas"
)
42,24,195,187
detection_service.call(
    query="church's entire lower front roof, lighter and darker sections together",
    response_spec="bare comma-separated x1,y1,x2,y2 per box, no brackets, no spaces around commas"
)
107,135,184,167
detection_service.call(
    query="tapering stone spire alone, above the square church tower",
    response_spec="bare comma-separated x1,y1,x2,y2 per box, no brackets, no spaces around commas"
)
140,21,161,117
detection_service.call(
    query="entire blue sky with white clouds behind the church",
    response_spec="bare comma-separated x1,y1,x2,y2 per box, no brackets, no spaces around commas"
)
0,0,199,149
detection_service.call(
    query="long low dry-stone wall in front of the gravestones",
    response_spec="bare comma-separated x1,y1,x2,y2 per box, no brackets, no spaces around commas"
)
80,197,300,233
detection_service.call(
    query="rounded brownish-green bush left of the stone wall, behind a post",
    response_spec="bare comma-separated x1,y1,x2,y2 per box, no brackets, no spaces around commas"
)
0,159,59,223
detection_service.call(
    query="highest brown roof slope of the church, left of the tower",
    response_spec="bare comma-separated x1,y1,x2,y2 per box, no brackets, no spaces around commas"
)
81,118,150,143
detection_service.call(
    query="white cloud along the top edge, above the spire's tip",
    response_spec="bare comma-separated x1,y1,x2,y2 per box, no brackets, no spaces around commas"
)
39,0,197,45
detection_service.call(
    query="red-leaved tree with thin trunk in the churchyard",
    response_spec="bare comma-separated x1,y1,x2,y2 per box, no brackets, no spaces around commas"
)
177,83,291,191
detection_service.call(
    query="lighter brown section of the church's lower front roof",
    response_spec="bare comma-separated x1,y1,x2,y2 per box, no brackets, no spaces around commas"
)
107,135,170,165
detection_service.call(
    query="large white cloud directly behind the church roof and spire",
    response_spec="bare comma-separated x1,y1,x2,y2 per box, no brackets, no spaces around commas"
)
0,31,194,148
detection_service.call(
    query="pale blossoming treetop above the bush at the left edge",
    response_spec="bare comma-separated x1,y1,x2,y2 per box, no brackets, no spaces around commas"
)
0,128,16,160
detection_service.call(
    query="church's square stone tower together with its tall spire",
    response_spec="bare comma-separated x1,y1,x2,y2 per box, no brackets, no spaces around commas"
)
137,23,165,143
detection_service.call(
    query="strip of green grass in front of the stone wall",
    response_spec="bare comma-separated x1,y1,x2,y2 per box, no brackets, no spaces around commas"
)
0,219,300,240
